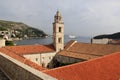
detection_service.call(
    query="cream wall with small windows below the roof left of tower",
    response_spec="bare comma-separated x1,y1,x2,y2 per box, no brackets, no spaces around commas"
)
23,52,56,67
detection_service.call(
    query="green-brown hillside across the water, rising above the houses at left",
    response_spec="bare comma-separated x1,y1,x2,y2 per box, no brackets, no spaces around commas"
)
0,20,46,38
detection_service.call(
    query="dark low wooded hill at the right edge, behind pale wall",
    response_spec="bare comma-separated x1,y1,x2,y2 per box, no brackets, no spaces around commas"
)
93,32,120,39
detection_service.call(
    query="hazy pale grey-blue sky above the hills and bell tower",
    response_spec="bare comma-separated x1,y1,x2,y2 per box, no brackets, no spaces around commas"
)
0,0,120,36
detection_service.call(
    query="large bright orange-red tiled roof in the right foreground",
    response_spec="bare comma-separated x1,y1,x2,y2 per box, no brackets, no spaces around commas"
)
43,52,120,80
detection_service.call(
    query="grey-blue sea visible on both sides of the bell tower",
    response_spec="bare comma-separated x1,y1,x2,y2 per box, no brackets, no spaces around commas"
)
14,36,91,45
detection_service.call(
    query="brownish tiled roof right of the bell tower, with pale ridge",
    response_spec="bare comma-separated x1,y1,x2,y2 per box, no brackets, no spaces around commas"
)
57,41,120,60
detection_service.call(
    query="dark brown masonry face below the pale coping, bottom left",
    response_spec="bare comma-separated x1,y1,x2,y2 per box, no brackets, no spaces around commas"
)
0,56,43,80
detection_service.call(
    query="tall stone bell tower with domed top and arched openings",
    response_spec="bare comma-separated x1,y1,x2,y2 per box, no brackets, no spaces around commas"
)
53,11,64,52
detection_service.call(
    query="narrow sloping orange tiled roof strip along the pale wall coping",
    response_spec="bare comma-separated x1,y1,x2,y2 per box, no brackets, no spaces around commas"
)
0,48,45,71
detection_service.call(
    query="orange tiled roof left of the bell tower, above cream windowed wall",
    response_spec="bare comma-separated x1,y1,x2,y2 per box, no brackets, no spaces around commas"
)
4,45,55,55
